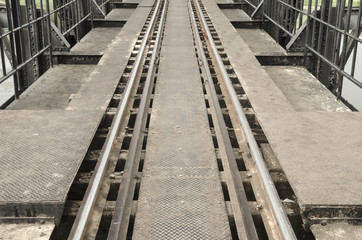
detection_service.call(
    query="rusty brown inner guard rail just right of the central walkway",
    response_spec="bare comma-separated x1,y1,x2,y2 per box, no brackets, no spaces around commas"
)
189,0,259,240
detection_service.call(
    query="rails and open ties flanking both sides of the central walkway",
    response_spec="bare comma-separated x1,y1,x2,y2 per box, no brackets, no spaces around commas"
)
52,0,313,240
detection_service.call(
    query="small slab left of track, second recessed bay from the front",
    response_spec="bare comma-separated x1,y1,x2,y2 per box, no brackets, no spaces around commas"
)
70,27,121,55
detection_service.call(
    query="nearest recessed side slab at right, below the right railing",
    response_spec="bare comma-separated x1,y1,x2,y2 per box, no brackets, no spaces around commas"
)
264,66,350,112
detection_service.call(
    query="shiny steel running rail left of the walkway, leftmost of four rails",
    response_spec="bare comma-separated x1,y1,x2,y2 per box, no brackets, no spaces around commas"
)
68,1,160,240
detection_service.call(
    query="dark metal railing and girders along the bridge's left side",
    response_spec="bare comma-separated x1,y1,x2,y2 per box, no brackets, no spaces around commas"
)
0,0,111,105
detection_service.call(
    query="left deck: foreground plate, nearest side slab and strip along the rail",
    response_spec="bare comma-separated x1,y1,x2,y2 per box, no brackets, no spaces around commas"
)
0,0,153,224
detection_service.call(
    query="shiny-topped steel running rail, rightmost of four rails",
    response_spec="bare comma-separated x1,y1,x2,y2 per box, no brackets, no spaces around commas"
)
194,0,296,240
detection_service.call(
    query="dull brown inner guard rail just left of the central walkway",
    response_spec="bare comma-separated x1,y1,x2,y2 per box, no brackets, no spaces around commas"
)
107,0,168,240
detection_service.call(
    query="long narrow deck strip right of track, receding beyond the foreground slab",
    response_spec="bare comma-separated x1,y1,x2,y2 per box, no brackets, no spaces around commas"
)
203,0,294,112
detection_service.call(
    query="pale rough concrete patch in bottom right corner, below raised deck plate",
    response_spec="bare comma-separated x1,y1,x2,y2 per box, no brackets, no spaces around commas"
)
311,222,362,240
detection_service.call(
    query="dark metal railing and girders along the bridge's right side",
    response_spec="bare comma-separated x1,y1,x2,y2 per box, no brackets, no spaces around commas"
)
242,0,362,98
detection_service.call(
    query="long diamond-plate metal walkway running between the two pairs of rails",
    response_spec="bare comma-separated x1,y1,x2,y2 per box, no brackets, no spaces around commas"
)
133,0,231,239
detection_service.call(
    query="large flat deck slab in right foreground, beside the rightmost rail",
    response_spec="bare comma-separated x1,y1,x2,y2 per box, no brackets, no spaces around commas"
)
259,112,362,208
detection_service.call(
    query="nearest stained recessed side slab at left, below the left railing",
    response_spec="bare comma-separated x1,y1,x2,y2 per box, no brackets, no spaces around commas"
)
7,65,94,110
